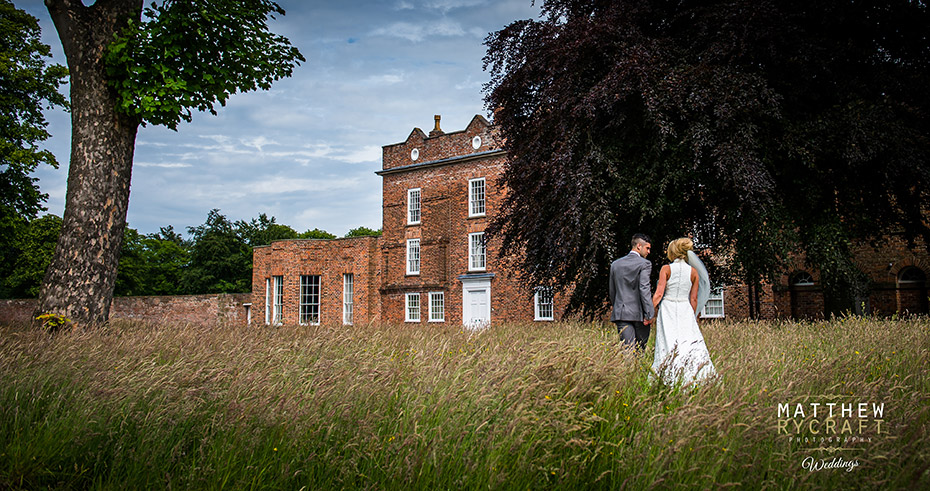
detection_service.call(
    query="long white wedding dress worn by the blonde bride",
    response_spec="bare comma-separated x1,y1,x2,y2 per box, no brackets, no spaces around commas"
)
652,259,717,385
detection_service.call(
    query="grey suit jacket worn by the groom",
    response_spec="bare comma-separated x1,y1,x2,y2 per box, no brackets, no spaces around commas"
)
610,251,655,322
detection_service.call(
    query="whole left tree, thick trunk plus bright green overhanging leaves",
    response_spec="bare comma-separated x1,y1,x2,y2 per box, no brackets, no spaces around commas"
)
37,0,304,325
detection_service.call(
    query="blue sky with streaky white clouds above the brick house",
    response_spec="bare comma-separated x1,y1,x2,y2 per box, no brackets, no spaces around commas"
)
13,0,539,236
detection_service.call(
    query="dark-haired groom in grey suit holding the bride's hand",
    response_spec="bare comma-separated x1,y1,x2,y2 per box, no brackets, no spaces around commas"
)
610,234,655,350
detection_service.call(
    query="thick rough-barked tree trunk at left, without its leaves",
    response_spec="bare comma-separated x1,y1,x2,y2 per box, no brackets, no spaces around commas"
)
36,0,142,325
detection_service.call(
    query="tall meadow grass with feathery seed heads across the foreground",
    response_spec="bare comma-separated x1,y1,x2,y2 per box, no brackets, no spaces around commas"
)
0,317,930,489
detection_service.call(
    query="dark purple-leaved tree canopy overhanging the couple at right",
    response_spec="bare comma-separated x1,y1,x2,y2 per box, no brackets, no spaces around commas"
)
485,0,930,313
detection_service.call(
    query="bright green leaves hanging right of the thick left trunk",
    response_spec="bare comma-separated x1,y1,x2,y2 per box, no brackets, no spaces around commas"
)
106,0,305,129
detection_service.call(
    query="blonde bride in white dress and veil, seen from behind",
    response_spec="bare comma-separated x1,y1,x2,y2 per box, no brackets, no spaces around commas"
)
652,237,717,385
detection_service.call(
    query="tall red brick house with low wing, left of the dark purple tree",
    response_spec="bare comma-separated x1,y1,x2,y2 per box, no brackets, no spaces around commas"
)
252,115,562,326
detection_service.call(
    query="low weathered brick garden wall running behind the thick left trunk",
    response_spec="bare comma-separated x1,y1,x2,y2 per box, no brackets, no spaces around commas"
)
0,293,255,325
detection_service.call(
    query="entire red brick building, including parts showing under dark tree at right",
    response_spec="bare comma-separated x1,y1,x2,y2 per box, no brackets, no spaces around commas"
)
252,115,930,326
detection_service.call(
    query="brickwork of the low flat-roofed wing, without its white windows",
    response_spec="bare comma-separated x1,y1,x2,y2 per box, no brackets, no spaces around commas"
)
252,237,381,324
